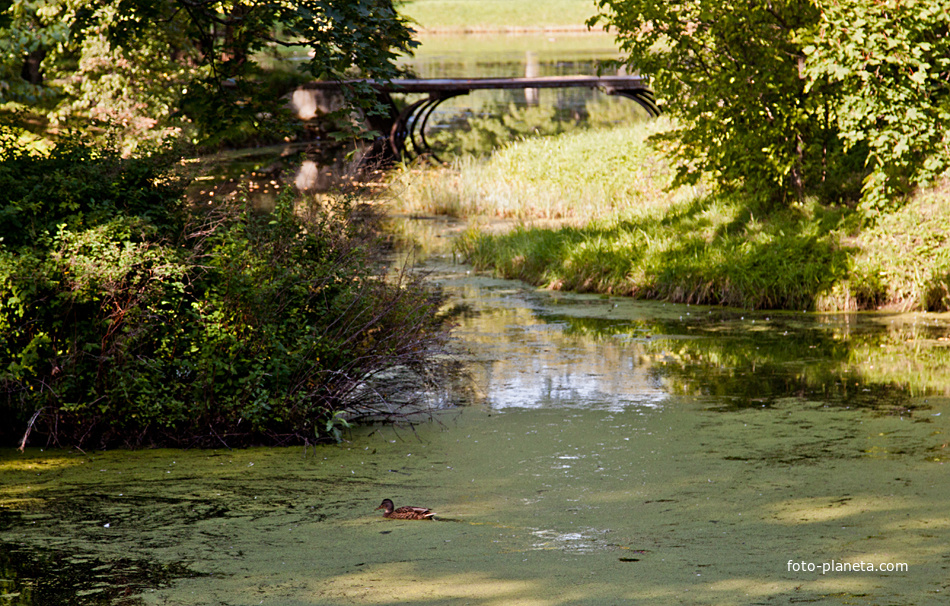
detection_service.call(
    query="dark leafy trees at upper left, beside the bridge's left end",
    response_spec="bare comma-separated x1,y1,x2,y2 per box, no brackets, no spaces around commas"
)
0,0,415,148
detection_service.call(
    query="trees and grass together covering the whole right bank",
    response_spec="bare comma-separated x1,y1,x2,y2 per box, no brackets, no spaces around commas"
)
388,0,950,311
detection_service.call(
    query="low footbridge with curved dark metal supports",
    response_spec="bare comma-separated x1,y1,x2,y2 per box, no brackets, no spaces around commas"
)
301,76,660,160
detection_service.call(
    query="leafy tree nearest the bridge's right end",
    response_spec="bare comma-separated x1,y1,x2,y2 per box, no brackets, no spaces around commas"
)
590,0,852,204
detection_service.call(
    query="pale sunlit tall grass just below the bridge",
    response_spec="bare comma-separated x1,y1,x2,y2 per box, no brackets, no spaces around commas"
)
390,121,697,225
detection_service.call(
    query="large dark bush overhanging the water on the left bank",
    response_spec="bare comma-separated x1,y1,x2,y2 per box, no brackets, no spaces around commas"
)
0,134,443,446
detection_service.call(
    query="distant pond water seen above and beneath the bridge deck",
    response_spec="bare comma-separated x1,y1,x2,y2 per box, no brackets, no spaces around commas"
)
397,32,649,159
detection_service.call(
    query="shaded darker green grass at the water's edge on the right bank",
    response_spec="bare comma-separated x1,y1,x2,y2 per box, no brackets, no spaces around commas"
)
458,196,848,309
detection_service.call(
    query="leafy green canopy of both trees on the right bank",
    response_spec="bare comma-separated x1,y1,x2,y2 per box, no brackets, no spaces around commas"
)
589,0,950,205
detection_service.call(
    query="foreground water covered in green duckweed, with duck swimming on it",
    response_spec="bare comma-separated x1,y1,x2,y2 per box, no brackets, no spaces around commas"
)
0,258,950,606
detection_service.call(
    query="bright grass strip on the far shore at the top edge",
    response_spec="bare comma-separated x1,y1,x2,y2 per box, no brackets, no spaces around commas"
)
397,0,596,31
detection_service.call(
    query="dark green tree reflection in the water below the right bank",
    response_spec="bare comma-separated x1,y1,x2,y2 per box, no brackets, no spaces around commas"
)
567,316,950,410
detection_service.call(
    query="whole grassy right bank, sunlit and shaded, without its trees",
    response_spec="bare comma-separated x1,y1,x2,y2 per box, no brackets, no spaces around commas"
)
393,122,950,310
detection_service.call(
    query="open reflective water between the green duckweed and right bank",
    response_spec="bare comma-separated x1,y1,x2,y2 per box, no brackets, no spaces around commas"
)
435,256,950,417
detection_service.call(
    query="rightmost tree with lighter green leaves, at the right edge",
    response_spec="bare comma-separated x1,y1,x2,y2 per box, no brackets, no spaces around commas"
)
802,0,950,207
